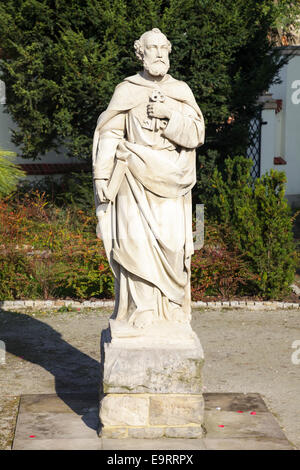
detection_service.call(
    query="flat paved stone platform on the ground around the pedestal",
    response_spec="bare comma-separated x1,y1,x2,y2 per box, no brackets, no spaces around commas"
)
13,393,293,450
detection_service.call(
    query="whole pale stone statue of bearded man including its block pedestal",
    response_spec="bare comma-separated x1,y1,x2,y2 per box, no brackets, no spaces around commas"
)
93,28,204,439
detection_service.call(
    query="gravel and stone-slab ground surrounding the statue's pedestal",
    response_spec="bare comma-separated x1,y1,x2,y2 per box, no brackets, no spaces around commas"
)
0,308,300,450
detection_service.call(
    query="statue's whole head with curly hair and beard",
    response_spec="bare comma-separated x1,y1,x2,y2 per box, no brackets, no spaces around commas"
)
134,28,171,77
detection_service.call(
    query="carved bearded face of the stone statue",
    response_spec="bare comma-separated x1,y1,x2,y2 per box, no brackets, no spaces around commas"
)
143,32,170,76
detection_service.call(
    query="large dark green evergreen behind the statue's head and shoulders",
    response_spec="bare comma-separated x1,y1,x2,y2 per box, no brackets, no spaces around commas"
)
0,0,291,165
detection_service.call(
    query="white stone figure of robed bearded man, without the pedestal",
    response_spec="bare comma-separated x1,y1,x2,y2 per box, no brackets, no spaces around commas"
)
93,28,204,328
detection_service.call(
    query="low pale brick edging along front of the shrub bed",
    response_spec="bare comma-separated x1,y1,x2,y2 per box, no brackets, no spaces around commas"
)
0,300,300,310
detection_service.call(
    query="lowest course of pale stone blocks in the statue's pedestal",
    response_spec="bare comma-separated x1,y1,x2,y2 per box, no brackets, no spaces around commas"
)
100,393,204,439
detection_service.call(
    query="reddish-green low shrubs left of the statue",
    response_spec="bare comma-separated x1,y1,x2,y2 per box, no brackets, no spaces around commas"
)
0,191,114,300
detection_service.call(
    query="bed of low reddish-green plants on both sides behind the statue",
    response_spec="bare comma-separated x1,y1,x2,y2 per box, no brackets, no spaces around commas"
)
0,185,297,302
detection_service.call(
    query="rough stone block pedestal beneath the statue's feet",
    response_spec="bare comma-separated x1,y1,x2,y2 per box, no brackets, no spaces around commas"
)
100,320,204,439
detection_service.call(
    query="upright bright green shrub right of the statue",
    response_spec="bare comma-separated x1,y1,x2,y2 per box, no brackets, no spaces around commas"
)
211,157,296,298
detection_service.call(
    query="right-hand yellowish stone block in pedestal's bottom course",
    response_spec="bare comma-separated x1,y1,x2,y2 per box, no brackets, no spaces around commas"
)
149,395,204,426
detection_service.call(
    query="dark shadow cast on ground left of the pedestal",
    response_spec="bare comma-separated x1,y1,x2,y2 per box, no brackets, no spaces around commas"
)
0,311,106,430
